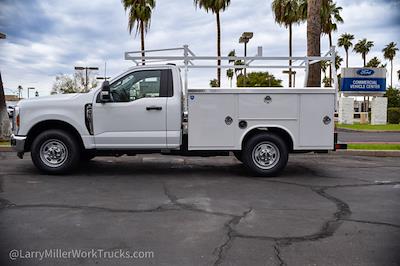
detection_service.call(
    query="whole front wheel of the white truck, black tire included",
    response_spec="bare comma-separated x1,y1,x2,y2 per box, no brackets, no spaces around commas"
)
31,129,81,174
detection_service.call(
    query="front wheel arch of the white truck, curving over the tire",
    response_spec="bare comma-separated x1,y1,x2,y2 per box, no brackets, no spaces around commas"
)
25,120,85,151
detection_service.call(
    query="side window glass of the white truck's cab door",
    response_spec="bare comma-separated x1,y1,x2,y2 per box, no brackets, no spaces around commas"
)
110,70,162,102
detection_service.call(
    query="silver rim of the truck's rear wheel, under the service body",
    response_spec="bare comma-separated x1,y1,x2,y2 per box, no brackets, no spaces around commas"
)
252,141,280,170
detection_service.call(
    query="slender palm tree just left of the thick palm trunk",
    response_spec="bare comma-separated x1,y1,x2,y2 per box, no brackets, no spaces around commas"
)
272,0,304,87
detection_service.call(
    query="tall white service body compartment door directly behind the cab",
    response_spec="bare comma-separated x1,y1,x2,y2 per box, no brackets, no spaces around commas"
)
188,93,238,150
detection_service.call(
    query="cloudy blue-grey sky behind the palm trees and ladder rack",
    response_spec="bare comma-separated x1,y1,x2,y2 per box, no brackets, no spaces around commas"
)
0,0,400,95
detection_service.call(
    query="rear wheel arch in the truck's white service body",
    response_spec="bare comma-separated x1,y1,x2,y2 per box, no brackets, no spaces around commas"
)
240,126,294,151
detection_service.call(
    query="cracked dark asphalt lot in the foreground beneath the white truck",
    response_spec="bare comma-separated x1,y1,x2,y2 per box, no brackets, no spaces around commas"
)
0,154,400,266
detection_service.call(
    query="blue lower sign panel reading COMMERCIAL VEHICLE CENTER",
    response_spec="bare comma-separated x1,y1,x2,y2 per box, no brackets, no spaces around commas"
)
341,78,386,92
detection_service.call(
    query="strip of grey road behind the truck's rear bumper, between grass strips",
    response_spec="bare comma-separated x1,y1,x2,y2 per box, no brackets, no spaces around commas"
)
338,129,400,143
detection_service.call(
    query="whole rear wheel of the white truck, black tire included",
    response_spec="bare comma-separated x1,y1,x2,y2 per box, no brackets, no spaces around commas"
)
242,133,289,177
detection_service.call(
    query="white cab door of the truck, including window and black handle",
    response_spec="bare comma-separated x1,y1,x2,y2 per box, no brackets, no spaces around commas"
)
93,70,168,149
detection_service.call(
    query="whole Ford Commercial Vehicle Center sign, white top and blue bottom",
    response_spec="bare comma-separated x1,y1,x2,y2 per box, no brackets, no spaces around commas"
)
341,68,386,94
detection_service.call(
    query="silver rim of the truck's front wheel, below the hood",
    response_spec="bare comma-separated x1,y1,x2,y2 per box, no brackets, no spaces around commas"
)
40,139,68,168
